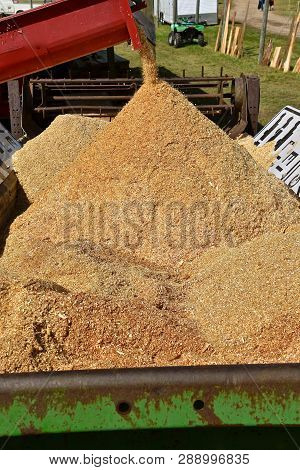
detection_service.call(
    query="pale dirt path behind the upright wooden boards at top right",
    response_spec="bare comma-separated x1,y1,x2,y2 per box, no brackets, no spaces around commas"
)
234,0,300,37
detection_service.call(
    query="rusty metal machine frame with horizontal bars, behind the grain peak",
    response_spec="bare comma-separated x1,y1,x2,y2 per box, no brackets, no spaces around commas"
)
24,73,260,138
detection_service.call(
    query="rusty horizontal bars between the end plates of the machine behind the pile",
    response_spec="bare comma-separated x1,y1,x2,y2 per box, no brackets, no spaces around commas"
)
30,77,234,117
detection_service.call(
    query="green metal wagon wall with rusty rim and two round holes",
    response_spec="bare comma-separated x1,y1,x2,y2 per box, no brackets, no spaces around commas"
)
0,364,300,436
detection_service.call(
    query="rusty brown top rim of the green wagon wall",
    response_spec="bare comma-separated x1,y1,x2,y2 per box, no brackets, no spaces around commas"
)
0,364,300,394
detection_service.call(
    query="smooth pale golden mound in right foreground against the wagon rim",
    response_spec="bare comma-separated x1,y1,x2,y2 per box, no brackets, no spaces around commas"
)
186,231,300,363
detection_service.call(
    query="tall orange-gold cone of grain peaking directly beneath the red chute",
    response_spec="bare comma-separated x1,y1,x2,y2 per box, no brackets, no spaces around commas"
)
1,82,300,280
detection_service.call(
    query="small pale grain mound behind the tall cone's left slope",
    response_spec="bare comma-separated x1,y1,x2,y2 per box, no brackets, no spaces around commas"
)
13,114,108,203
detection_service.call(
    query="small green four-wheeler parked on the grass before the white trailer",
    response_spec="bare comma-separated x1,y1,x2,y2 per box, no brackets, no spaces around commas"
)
168,18,207,48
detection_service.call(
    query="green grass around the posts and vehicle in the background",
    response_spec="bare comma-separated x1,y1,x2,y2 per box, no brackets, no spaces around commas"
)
116,26,300,124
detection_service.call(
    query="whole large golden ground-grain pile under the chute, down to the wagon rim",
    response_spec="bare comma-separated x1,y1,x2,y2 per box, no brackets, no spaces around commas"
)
0,43,300,372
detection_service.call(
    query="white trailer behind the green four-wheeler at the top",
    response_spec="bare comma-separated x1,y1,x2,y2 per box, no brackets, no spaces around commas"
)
154,0,218,25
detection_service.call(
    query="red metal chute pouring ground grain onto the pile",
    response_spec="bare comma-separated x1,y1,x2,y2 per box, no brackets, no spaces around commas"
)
0,0,145,83
